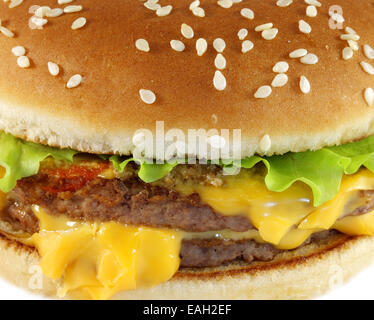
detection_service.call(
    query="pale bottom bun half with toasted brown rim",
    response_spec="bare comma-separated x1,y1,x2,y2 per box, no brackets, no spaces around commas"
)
0,230,374,299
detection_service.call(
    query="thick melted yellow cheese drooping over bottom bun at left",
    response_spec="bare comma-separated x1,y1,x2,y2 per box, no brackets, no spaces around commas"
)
28,206,181,299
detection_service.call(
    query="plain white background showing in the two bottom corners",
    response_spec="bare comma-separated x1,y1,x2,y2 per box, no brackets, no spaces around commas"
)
0,265,374,300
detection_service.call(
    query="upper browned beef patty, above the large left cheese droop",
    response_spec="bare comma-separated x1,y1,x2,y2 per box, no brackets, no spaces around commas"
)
3,174,253,232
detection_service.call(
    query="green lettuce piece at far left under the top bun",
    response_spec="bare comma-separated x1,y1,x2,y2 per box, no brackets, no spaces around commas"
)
0,132,77,192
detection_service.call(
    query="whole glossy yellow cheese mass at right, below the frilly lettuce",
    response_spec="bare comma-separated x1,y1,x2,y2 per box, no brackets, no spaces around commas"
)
177,169,374,249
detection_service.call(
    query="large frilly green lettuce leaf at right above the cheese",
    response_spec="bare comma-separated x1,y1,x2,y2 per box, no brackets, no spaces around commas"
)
226,136,374,207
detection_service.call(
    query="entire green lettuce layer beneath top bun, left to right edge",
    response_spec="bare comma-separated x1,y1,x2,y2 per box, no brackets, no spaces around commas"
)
0,132,374,206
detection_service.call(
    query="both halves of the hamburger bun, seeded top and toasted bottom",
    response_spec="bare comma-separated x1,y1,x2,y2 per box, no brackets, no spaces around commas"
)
0,0,374,299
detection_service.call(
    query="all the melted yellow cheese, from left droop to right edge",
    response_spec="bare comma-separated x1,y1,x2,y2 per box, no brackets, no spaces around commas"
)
16,170,374,299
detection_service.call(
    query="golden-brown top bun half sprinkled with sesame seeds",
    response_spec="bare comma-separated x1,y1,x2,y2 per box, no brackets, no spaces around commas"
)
0,0,374,156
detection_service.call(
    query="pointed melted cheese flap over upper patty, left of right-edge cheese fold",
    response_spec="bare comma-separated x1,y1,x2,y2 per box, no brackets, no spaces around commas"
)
177,170,314,244
